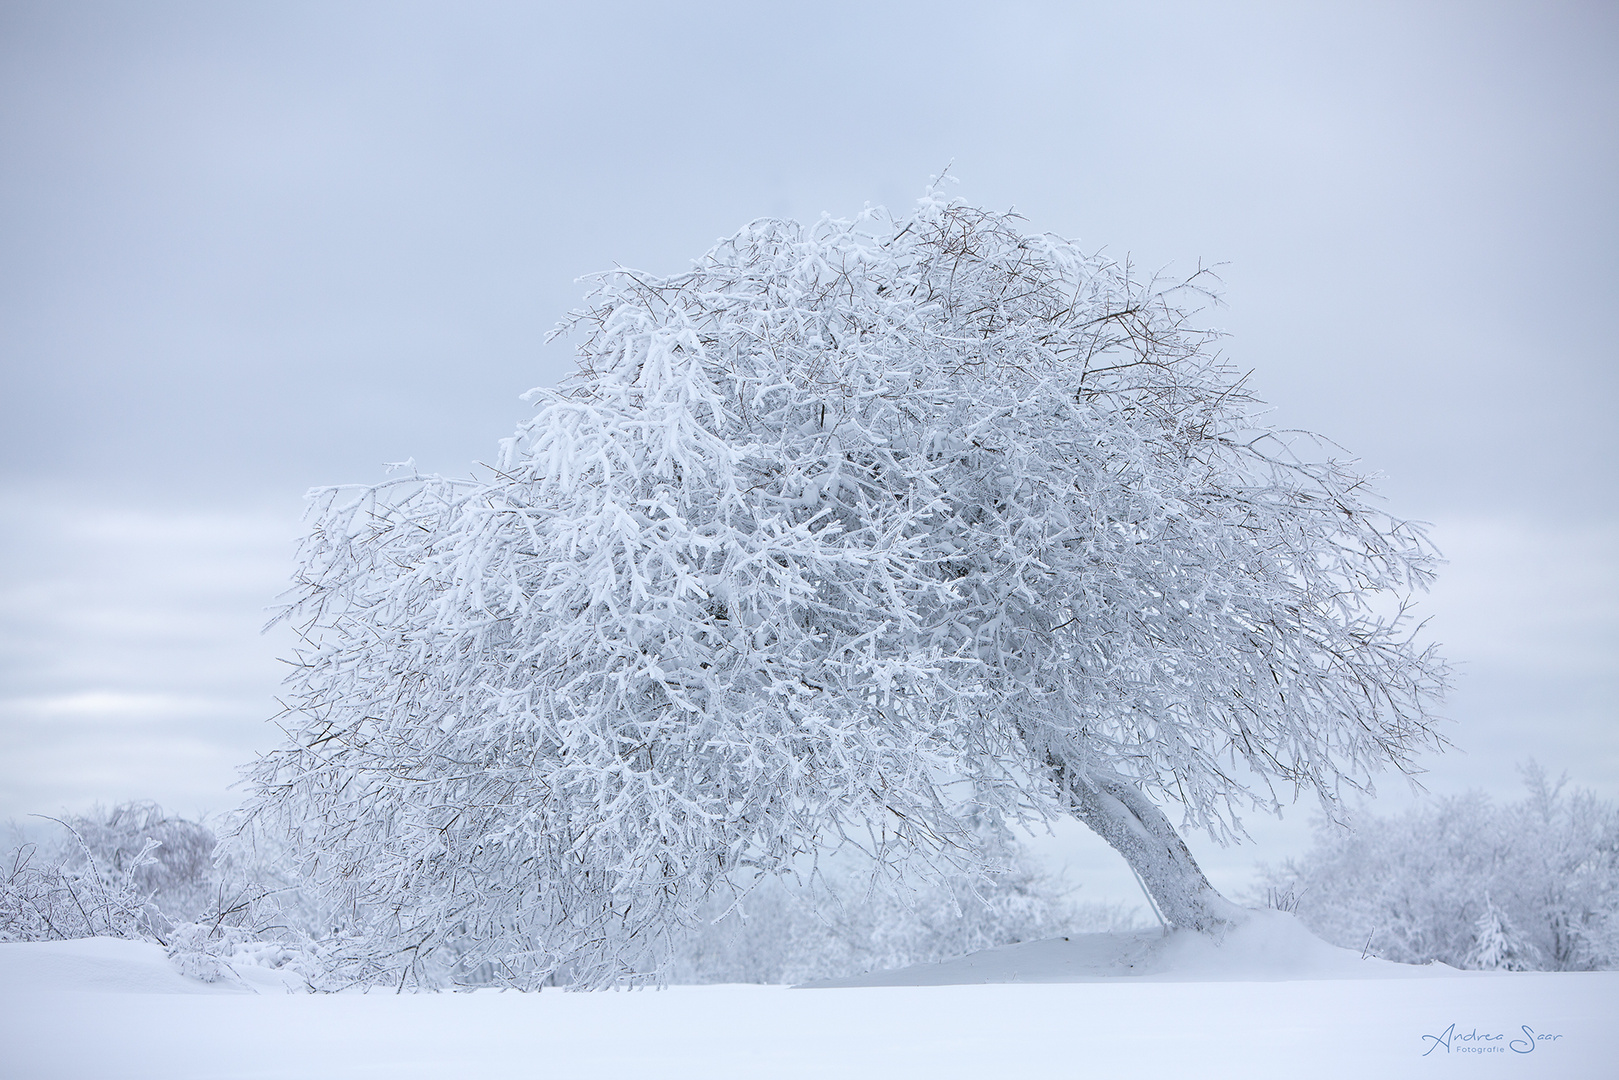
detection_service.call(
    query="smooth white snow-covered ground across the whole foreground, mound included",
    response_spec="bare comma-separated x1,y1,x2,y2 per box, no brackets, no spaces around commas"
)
0,915,1619,1080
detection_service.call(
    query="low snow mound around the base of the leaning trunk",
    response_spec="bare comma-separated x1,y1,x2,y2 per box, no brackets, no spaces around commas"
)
803,910,1478,989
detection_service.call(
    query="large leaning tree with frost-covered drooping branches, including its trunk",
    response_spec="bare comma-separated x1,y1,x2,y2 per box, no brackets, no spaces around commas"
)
254,193,1444,986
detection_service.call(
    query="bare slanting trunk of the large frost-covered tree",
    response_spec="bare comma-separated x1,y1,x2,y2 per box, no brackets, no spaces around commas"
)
1064,772,1247,934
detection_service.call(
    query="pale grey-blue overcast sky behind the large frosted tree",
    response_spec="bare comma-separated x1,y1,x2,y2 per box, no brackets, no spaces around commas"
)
0,0,1619,894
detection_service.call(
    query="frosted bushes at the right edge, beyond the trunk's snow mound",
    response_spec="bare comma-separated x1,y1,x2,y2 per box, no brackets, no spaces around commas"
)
1264,764,1619,972
